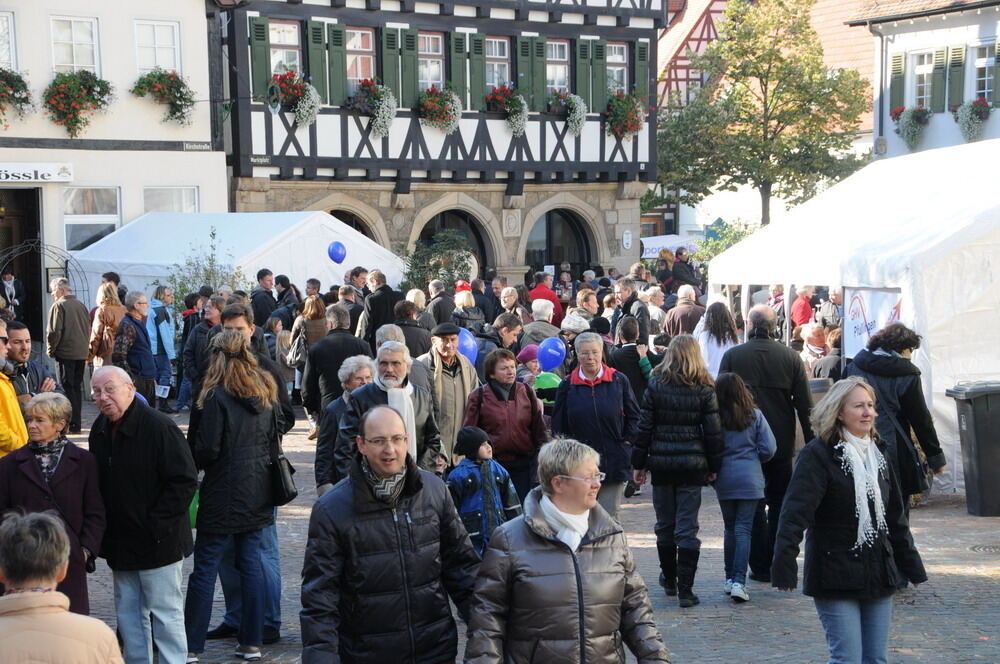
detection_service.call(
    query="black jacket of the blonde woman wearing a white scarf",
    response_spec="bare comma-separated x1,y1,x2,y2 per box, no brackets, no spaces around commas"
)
771,439,927,599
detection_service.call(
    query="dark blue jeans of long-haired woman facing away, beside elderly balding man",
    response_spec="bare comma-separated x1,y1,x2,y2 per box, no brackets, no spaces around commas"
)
184,530,264,654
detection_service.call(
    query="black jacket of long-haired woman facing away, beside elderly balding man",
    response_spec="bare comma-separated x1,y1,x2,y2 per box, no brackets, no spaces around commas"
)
194,386,281,535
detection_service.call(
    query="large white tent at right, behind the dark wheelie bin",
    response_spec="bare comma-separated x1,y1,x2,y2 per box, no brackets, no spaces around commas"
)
709,140,1000,490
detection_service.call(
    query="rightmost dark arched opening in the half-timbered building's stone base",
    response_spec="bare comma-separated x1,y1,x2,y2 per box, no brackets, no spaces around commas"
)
524,209,593,283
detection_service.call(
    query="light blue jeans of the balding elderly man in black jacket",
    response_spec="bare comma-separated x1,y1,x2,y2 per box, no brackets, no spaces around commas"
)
112,560,188,664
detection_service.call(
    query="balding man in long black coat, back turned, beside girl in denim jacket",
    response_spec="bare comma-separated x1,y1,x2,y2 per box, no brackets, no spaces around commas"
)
719,304,812,581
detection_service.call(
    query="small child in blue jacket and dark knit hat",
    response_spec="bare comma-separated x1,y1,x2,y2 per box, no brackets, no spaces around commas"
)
448,427,521,556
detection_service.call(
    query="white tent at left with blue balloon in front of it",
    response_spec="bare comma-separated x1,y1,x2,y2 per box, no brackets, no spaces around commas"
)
75,212,404,293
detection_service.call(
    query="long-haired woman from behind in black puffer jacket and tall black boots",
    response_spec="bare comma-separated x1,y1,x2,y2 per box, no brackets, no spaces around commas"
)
632,334,723,607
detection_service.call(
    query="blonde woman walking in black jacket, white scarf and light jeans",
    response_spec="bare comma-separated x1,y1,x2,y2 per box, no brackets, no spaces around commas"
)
771,376,927,664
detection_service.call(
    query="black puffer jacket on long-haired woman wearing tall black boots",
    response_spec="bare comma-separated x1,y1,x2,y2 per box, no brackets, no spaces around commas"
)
632,376,722,484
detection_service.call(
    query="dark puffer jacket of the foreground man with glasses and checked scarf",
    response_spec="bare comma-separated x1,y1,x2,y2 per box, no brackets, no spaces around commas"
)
300,458,479,664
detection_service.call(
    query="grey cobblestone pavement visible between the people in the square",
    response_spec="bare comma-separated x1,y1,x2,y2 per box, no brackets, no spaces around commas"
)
74,403,1000,664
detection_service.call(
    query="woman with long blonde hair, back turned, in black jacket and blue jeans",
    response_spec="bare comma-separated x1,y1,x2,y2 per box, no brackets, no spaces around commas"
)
184,330,282,662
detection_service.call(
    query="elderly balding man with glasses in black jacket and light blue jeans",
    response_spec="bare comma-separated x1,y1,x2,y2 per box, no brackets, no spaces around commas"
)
89,366,198,662
